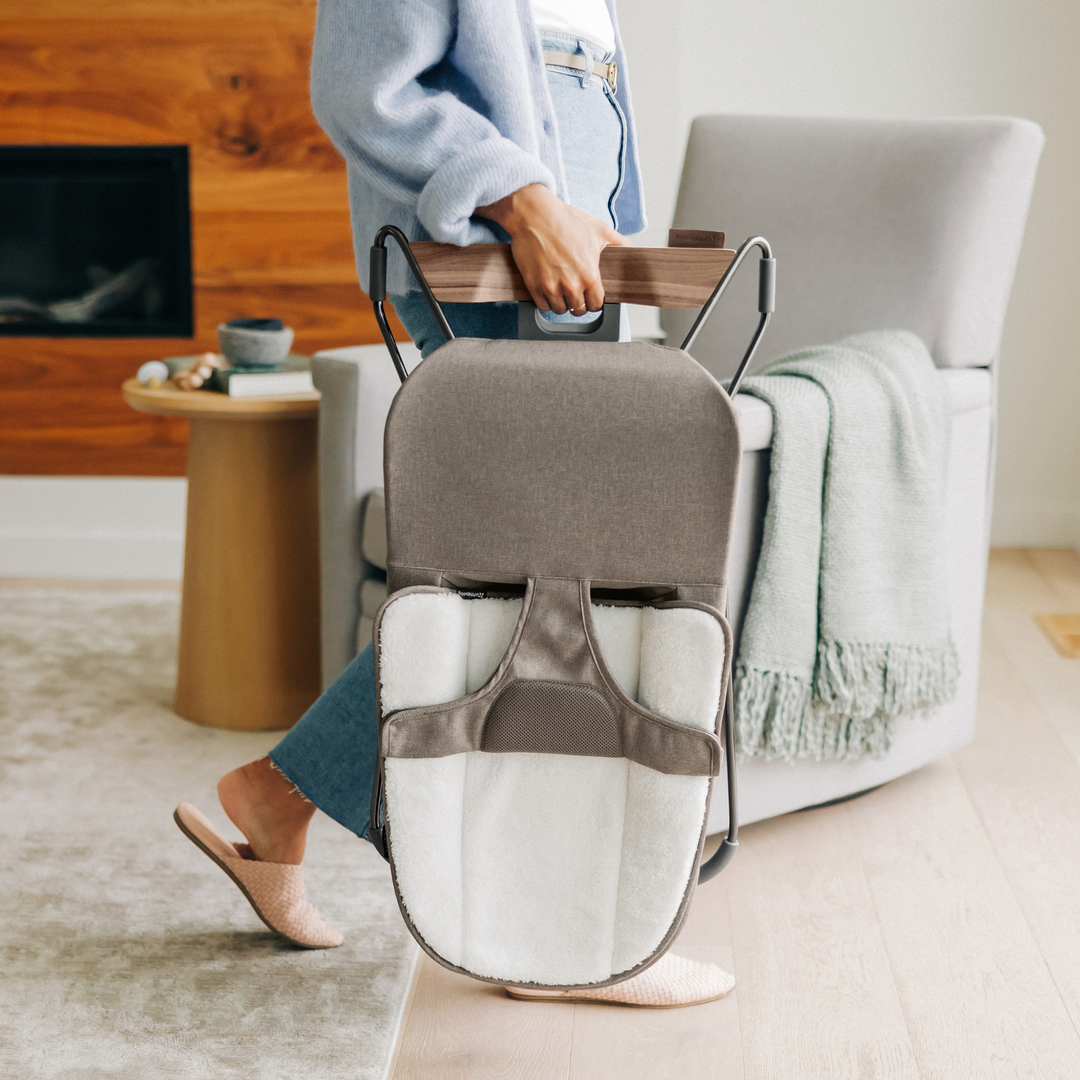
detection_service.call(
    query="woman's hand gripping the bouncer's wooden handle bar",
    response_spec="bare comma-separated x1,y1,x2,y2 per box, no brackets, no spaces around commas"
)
476,184,629,315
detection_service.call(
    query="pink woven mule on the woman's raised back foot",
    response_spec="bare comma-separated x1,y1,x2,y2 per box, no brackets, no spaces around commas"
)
173,802,345,948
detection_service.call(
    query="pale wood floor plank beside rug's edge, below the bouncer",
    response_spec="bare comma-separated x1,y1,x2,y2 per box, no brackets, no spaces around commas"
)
392,956,575,1080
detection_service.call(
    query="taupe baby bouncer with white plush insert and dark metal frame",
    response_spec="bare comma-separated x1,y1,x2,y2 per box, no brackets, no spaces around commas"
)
370,226,775,990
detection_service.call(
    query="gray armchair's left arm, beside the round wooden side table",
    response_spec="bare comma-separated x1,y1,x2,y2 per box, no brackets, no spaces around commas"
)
311,342,420,688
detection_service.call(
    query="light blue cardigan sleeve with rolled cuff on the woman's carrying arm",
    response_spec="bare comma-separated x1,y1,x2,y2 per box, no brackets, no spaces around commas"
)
311,0,556,244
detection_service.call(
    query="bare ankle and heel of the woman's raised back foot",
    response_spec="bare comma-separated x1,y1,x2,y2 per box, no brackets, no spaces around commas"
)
217,757,315,866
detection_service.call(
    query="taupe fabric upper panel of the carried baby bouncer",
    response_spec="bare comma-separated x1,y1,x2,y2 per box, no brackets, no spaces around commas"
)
383,338,742,607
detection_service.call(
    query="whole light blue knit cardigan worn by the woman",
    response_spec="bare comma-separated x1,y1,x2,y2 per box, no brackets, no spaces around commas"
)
311,0,646,293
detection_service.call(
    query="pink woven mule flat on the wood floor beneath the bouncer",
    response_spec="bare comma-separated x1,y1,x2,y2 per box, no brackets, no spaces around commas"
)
507,953,735,1009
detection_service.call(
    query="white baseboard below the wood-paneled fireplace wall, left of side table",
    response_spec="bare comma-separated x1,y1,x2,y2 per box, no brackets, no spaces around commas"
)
0,476,188,581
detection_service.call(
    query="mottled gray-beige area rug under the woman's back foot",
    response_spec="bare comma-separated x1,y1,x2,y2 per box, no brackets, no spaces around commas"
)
0,592,417,1080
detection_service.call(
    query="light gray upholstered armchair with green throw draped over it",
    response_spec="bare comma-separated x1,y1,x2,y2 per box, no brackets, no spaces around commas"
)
314,117,1043,832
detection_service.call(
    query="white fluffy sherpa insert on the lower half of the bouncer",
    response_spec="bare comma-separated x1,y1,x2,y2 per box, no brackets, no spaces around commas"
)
380,593,725,986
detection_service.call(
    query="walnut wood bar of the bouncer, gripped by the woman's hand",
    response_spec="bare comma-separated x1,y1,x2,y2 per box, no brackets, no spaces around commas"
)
411,241,735,308
